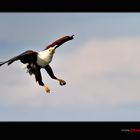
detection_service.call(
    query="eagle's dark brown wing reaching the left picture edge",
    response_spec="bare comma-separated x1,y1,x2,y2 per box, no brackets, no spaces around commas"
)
0,50,37,66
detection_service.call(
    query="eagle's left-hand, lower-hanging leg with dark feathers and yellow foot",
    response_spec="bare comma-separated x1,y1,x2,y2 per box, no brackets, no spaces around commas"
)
34,66,50,93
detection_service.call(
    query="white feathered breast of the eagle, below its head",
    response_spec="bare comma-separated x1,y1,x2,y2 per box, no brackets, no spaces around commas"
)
37,50,53,67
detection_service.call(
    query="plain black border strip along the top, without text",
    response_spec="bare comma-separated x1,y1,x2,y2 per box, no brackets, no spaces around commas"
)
0,0,140,12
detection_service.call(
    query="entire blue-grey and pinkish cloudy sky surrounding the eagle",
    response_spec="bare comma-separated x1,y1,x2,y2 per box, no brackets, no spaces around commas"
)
0,12,140,121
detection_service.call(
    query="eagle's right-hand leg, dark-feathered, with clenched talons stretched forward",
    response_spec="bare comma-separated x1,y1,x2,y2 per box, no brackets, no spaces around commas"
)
45,65,66,86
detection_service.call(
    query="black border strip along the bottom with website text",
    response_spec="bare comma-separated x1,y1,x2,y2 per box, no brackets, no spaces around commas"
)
0,122,140,140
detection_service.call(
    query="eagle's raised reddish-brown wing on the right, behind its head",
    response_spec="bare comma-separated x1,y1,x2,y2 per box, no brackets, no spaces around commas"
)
44,35,74,50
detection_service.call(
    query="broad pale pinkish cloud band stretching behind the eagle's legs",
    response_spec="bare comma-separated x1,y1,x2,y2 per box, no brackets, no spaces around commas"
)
0,38,140,108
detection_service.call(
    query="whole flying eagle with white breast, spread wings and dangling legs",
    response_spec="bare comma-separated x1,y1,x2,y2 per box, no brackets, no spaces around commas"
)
0,35,74,93
